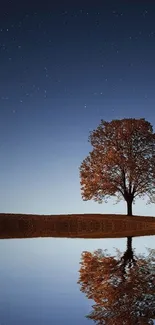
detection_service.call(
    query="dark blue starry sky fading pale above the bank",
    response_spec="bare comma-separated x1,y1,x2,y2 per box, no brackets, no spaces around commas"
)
0,0,155,215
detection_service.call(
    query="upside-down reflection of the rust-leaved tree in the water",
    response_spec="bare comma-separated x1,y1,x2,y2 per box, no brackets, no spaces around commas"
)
78,237,155,325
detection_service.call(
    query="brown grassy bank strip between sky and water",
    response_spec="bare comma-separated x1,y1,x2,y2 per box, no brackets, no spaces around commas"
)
0,213,155,239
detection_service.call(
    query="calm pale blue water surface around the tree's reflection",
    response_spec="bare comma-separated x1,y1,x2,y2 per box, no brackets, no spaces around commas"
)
0,236,155,325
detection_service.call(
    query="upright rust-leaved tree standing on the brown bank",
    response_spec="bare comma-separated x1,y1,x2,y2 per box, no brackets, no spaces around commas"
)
79,118,155,215
